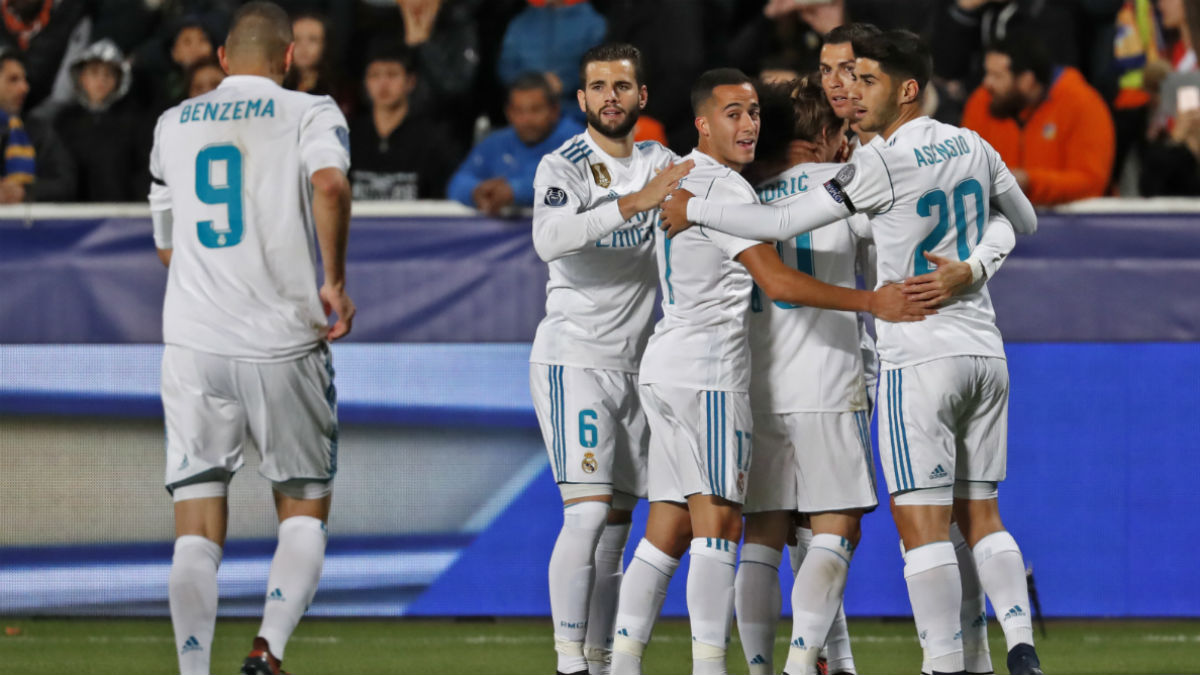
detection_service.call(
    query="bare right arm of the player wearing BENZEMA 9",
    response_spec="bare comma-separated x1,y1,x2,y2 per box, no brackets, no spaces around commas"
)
312,167,355,340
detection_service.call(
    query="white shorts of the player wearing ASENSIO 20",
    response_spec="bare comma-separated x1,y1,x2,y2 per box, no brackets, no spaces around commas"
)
878,357,1008,495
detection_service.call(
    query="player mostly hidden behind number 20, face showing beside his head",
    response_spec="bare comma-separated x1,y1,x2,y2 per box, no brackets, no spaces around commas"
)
820,23,1010,673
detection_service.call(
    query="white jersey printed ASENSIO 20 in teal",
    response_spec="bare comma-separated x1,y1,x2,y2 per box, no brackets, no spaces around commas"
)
835,118,1016,369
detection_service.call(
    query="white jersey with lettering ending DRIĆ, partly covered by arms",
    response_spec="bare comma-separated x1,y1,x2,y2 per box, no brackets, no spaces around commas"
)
750,165,870,413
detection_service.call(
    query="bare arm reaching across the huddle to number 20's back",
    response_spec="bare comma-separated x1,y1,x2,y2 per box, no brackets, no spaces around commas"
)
737,244,937,323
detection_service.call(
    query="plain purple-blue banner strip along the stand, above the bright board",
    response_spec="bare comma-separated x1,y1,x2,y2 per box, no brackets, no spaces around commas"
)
0,204,1200,344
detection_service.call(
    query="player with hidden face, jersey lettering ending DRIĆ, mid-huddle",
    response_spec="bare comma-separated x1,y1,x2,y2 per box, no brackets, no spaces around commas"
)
736,78,1014,675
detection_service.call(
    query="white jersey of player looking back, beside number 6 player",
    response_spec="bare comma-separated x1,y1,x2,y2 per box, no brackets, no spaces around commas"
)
638,150,761,392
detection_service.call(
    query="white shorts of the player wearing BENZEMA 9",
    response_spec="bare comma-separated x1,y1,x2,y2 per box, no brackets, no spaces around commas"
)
162,344,337,492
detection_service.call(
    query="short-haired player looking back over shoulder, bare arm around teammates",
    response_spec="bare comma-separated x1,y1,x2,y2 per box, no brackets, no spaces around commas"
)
612,68,929,675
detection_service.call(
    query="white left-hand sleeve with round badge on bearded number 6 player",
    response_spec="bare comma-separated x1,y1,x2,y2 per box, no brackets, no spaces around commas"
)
533,153,625,263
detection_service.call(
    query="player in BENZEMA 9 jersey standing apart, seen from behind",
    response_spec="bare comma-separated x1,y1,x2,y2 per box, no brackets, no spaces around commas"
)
150,2,354,675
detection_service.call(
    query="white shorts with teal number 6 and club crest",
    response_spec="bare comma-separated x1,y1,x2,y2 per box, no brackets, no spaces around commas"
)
529,363,649,500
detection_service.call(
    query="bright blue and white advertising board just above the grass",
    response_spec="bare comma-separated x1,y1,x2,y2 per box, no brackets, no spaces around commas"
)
0,344,1200,616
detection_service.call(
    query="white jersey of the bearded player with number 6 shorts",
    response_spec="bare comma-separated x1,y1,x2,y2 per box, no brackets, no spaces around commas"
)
529,131,678,372
